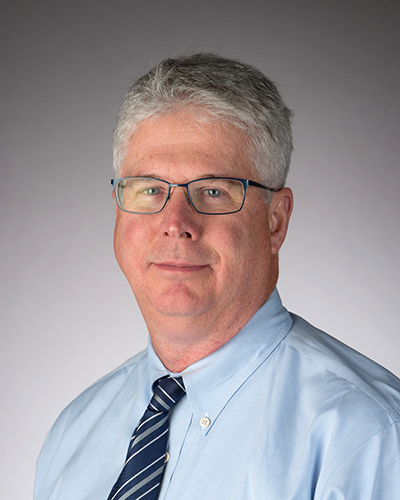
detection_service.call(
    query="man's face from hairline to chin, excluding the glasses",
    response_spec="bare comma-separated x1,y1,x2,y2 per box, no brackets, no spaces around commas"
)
114,112,292,340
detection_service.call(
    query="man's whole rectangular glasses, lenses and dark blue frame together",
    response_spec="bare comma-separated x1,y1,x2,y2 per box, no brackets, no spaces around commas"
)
111,177,278,215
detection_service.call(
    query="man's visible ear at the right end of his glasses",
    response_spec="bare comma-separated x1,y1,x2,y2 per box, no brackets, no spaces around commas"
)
268,188,293,254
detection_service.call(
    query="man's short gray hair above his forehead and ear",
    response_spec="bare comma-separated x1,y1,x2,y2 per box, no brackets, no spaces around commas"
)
113,53,293,189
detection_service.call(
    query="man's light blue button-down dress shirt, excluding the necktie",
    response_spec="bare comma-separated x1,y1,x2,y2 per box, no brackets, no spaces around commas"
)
35,291,400,500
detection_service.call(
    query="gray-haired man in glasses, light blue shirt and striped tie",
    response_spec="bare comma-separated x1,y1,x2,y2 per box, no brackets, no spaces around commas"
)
35,54,400,500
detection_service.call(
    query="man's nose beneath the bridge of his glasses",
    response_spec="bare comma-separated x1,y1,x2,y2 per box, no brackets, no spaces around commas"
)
160,187,200,241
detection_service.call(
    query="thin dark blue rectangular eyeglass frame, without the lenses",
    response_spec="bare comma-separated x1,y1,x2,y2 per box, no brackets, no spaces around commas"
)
111,176,280,215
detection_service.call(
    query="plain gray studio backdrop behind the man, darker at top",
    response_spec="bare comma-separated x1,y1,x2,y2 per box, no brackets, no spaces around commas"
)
0,0,400,499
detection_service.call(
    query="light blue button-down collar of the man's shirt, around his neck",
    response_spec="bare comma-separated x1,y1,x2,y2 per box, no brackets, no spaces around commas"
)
148,289,292,434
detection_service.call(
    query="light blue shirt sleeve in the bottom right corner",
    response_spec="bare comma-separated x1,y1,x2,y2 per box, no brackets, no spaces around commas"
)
316,421,400,500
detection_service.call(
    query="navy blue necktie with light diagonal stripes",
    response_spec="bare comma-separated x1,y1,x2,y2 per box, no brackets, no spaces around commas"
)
107,377,185,500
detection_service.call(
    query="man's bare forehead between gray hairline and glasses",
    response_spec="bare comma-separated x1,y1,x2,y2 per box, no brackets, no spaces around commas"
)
122,112,254,182
